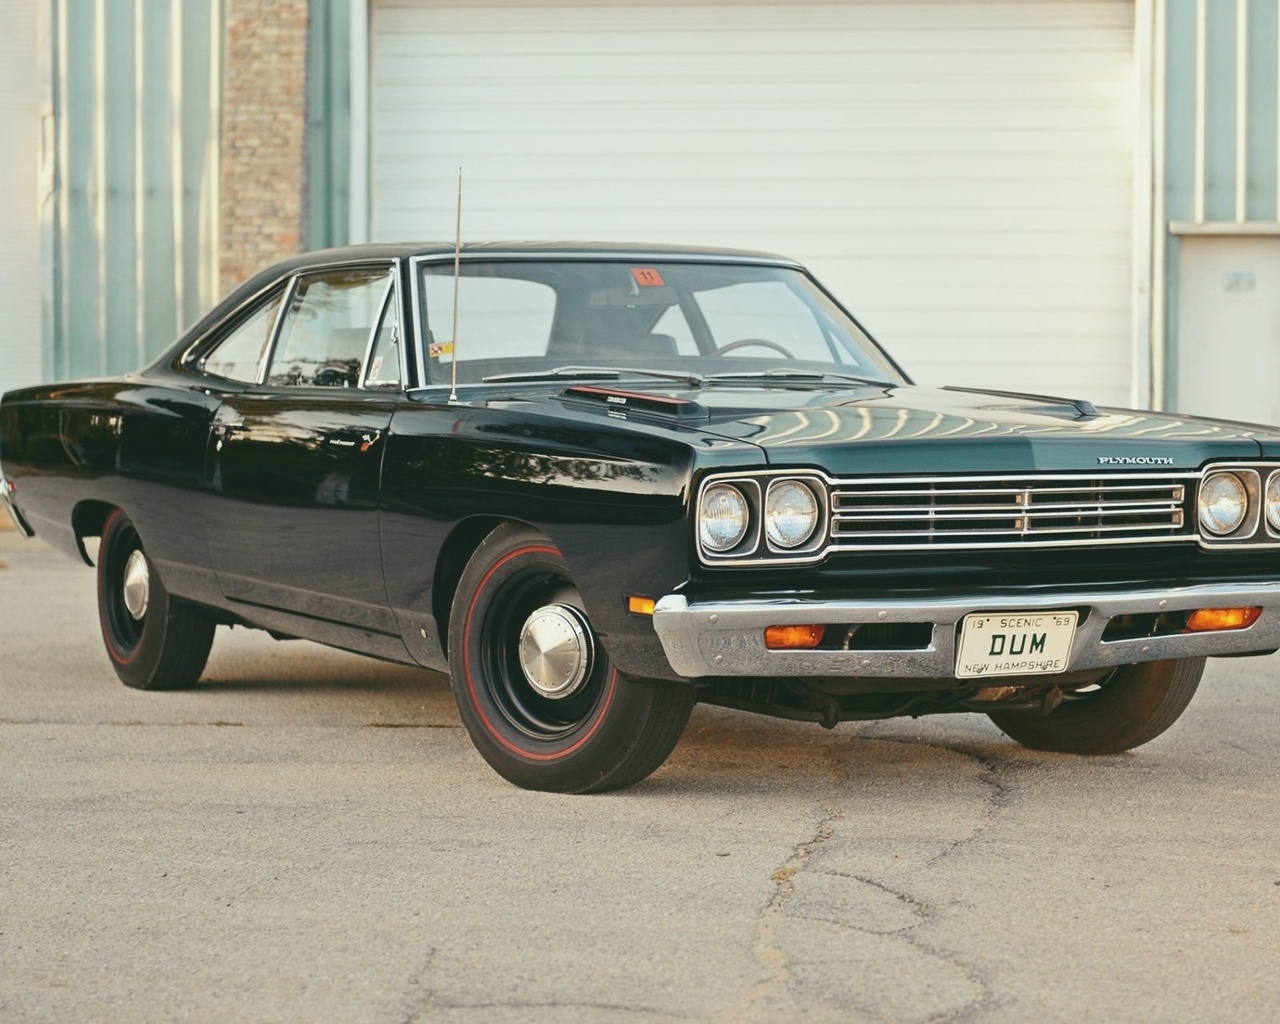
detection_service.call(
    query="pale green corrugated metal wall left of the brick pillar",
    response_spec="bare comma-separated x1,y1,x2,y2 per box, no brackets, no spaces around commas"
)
41,0,224,379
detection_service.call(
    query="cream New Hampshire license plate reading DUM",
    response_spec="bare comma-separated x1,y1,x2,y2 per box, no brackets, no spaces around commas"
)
956,612,1079,678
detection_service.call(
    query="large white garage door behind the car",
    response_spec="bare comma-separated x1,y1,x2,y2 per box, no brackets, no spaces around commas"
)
370,0,1134,403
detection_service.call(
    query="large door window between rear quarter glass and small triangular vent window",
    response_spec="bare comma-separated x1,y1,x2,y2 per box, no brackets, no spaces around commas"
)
266,266,388,388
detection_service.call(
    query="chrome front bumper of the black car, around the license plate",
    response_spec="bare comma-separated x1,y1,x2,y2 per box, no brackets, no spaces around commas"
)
653,582,1280,678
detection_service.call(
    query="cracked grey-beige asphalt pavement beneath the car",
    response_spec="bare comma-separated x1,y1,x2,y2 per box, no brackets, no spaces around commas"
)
0,532,1280,1024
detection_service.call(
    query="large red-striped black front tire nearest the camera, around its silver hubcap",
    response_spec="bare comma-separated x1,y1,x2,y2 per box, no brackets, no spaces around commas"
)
449,524,695,792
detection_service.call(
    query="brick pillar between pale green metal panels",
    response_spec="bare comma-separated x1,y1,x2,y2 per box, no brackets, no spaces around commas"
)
219,0,307,292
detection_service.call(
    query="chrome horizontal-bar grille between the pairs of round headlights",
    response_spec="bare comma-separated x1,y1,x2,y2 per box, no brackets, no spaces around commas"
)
831,474,1197,550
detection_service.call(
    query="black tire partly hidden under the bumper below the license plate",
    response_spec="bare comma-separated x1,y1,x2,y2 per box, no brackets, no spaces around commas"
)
987,658,1204,754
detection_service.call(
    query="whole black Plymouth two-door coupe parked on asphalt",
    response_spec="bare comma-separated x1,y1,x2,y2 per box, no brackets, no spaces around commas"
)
0,244,1280,792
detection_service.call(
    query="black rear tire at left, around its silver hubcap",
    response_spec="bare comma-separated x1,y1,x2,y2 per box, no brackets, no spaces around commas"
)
97,508,215,690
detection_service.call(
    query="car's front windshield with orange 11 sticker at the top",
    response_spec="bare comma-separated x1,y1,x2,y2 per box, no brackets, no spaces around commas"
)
421,260,900,384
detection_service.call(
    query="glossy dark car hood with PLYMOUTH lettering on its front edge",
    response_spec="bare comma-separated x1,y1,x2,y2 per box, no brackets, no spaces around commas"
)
545,381,1280,475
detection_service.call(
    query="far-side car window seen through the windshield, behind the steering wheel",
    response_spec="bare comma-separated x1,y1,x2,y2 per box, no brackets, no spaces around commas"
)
698,280,831,362
